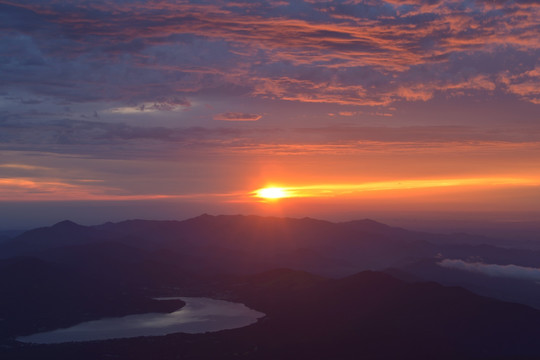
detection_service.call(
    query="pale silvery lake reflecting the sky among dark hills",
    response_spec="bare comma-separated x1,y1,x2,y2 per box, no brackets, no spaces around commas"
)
17,297,264,344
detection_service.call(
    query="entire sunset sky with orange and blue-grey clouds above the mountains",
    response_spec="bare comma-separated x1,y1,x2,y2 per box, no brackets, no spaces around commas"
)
0,0,540,229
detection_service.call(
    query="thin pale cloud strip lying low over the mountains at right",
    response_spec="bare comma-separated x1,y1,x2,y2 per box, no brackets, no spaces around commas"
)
437,259,540,281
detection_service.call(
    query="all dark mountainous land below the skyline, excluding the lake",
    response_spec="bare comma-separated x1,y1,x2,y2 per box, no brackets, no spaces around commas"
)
0,215,540,359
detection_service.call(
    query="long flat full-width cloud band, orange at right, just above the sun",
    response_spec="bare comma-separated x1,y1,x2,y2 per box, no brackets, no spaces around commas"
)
0,113,540,161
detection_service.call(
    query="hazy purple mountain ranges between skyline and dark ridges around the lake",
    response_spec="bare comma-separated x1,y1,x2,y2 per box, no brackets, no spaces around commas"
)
4,214,540,308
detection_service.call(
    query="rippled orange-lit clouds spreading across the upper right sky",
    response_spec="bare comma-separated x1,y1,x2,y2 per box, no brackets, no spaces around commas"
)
4,0,540,109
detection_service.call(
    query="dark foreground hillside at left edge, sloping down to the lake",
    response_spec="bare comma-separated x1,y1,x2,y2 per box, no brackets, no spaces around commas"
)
0,258,184,343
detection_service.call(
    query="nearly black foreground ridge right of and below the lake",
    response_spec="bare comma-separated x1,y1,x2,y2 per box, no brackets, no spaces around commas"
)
0,270,540,360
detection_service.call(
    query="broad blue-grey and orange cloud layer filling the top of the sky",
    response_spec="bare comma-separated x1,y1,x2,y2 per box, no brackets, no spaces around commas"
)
0,0,540,111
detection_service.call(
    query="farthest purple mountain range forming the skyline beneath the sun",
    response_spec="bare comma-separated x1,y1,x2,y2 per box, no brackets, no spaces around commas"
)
5,215,540,276
